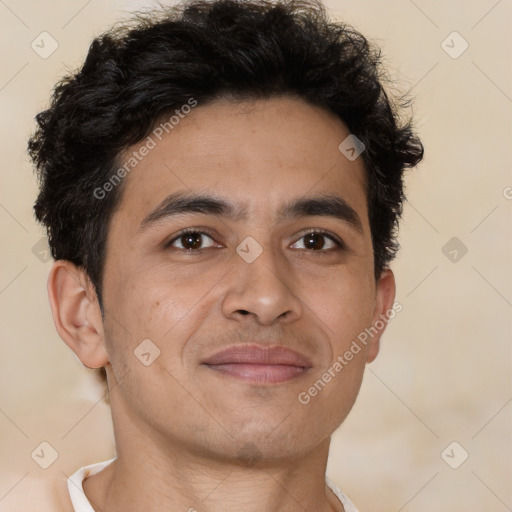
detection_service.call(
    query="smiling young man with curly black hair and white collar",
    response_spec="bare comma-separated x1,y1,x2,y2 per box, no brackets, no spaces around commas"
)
29,0,423,512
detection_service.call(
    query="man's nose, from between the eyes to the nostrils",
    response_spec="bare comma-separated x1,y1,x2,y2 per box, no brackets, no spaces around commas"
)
222,239,303,325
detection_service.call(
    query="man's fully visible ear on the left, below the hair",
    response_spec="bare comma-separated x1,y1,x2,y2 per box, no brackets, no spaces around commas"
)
47,260,108,368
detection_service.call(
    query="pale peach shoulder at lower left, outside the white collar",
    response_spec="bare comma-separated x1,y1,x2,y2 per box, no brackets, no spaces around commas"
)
0,473,74,512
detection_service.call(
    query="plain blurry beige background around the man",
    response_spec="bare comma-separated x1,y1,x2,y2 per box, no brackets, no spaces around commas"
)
0,0,512,512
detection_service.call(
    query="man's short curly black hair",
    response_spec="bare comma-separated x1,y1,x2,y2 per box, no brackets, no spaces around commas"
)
28,0,423,390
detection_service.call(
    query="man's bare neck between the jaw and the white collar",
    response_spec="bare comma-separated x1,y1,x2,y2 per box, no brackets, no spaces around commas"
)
83,372,344,512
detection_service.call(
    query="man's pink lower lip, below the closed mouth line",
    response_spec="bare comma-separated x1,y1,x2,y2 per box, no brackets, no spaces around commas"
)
206,363,307,383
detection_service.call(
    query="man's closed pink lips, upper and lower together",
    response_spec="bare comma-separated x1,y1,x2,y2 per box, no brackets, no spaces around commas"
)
203,345,312,383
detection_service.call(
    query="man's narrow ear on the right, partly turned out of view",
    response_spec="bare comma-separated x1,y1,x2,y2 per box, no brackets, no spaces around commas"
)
366,268,401,363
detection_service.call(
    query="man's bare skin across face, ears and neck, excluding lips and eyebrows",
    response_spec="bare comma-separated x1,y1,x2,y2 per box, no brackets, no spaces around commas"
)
48,97,395,512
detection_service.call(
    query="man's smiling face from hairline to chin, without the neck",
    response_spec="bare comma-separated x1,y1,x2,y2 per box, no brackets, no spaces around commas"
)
81,94,394,459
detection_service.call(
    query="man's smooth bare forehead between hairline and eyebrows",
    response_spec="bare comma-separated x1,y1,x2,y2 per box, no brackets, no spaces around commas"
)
118,97,366,225
